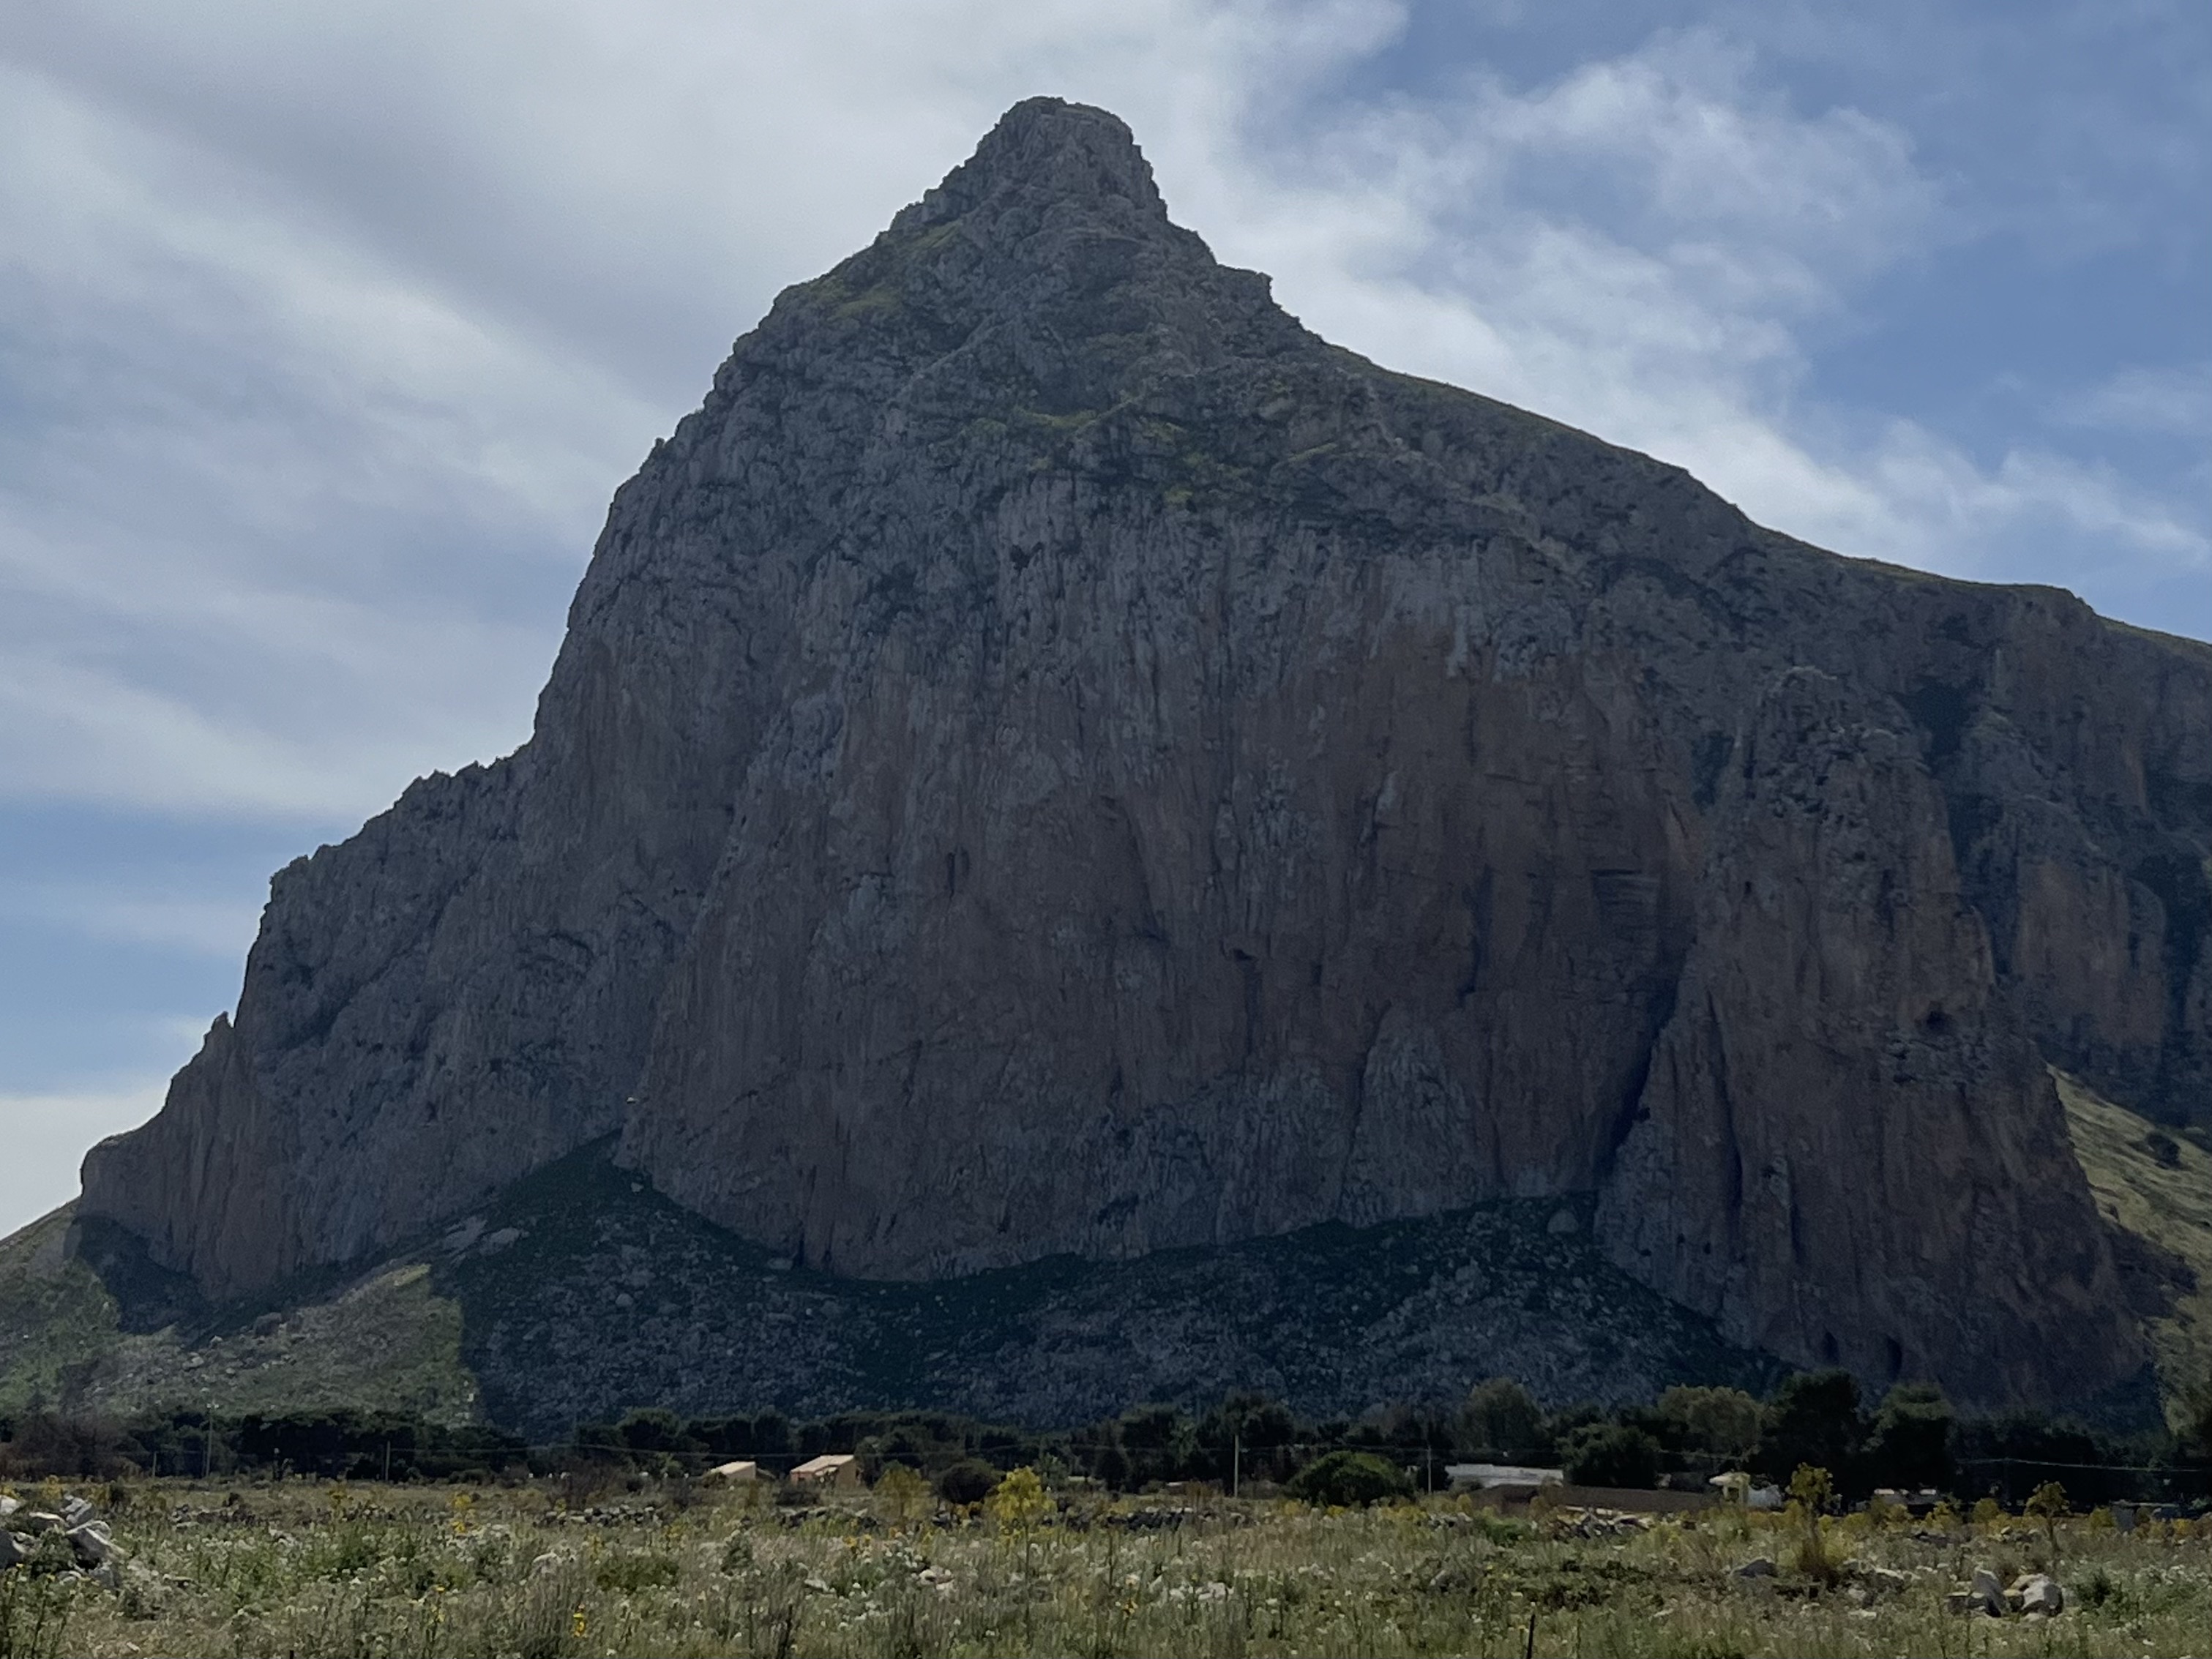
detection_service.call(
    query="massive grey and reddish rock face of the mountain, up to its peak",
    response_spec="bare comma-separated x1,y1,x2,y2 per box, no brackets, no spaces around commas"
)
73,100,2212,1400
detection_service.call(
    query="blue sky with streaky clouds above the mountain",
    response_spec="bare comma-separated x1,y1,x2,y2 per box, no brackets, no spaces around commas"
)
0,0,2212,1235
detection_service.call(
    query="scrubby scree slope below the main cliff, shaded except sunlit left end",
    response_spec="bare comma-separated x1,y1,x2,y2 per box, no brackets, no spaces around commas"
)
0,1146,1779,1440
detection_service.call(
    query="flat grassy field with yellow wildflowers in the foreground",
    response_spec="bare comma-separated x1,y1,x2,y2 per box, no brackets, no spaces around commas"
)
0,1480,2212,1659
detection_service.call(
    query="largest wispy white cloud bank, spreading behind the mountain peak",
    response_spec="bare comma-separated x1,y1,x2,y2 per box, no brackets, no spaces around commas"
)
0,0,2203,836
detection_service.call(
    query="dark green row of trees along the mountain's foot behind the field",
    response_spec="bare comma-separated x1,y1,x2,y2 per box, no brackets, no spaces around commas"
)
0,1371,2212,1506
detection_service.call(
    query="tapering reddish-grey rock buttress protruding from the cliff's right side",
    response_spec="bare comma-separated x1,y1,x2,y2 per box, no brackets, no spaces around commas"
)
1599,668,2126,1398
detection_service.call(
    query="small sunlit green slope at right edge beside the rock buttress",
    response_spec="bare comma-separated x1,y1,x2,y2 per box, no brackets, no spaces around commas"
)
2052,1073,2212,1427
